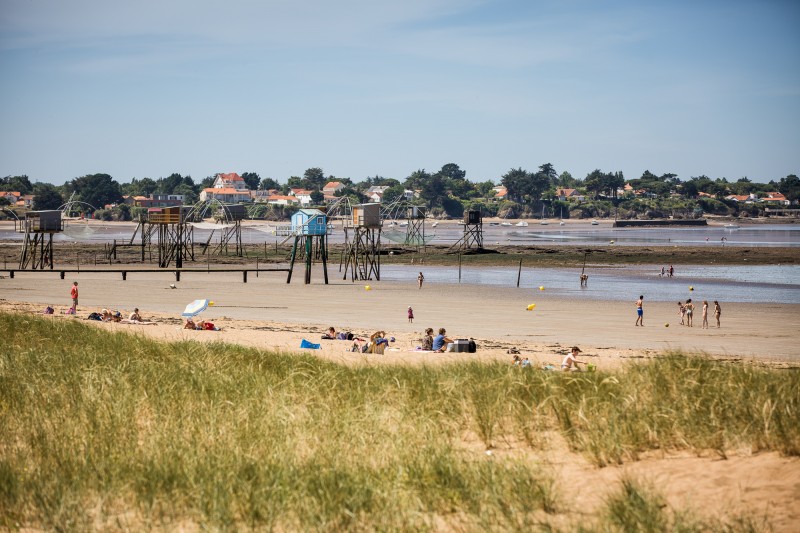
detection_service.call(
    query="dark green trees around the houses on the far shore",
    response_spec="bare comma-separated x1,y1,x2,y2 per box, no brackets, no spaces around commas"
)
0,163,800,218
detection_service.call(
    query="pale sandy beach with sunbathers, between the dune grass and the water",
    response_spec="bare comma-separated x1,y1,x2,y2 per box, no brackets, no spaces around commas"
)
0,271,800,368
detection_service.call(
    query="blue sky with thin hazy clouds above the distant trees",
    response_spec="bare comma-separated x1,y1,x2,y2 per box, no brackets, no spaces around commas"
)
0,0,800,184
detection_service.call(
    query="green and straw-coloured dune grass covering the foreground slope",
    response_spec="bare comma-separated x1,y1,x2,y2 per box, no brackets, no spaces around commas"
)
0,314,800,530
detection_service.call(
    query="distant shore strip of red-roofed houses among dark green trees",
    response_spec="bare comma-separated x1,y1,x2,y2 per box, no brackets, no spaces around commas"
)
0,163,800,220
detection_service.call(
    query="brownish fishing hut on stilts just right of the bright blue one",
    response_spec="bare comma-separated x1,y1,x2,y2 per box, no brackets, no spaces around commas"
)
340,204,381,281
